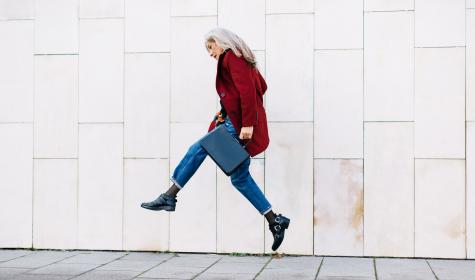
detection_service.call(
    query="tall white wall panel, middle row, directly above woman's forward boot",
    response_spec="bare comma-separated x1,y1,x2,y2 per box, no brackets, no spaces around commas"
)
124,53,170,158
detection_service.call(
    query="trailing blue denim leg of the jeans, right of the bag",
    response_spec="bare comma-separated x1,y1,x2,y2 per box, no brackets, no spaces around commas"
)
224,117,272,215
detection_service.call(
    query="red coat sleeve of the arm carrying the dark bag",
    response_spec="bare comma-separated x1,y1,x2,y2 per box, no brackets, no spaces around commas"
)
227,53,257,127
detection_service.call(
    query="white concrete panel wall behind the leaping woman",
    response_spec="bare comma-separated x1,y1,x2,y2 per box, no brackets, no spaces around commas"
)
0,0,475,258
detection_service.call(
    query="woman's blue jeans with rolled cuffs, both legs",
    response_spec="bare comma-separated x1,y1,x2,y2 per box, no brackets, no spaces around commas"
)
170,117,272,215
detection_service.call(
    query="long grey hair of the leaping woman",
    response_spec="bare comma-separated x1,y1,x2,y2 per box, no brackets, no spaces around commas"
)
205,27,257,67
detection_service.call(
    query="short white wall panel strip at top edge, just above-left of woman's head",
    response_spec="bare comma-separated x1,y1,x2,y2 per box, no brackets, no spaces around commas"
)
170,0,218,16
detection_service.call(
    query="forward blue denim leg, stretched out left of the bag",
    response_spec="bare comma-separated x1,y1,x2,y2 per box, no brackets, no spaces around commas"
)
170,136,208,189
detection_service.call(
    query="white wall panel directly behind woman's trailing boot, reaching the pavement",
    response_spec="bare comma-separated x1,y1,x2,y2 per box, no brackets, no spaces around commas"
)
265,122,313,255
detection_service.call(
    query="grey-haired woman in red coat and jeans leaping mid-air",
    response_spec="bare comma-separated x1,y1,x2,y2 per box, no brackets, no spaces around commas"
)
141,28,290,251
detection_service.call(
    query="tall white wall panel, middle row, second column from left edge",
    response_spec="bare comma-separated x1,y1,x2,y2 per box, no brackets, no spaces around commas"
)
34,55,78,158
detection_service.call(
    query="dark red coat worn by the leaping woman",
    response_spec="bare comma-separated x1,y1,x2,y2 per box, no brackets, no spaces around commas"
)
208,49,269,157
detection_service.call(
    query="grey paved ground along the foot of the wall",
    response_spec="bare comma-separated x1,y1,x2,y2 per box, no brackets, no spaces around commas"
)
0,249,475,280
